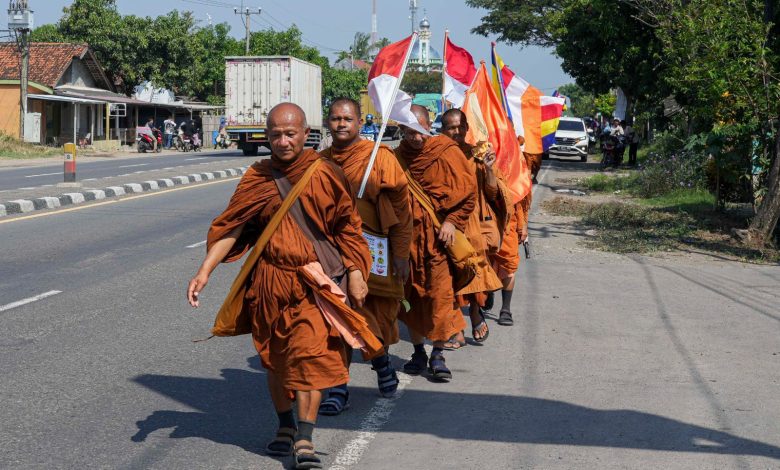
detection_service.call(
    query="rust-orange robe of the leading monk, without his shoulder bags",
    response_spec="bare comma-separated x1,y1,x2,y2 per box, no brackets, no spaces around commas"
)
208,150,371,391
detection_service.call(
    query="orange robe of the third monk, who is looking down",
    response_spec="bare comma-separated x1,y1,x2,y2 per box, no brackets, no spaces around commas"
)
396,136,476,341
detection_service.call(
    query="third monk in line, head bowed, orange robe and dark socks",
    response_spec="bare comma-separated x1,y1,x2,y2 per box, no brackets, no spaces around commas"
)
396,105,476,381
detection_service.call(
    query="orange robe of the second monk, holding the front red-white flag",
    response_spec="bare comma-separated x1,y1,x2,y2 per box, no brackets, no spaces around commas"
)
320,140,412,346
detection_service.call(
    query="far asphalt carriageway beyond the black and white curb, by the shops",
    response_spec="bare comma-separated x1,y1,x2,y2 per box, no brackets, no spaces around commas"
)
0,149,264,191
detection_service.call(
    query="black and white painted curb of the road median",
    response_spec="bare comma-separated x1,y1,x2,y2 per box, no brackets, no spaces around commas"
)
0,167,248,217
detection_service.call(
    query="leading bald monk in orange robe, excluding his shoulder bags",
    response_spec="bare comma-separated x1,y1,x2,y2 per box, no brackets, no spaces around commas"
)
187,103,371,468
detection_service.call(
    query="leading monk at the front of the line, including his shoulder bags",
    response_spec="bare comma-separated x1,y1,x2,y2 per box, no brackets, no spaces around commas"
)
187,103,374,468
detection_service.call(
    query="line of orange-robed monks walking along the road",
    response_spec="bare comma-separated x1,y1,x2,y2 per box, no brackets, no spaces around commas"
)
187,98,530,468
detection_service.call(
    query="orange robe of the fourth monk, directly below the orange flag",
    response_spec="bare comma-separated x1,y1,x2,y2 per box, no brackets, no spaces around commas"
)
456,144,506,307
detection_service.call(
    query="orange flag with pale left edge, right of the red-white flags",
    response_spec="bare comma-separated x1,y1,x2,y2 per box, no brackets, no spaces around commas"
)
462,62,531,203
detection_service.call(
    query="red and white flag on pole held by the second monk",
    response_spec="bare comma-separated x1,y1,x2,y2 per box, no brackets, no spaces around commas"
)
368,33,430,134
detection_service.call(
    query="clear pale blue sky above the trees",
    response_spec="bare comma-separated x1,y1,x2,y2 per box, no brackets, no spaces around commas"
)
29,0,574,93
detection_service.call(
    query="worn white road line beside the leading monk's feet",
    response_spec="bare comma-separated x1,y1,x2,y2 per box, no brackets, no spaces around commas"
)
329,372,412,470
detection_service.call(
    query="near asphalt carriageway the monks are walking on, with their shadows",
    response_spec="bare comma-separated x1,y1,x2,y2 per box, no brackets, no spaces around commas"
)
0,161,780,469
